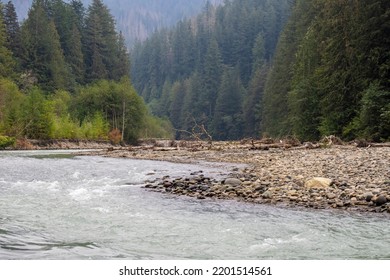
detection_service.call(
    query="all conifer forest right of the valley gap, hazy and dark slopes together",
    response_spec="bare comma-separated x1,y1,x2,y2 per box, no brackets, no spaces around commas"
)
131,0,390,141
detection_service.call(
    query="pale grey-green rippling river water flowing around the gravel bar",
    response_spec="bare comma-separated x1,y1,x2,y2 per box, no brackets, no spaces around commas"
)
0,151,390,260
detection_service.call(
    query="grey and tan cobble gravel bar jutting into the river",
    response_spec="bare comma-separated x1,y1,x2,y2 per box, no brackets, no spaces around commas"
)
78,142,390,213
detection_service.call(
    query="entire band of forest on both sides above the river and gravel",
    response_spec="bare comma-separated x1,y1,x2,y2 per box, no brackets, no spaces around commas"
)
0,0,390,148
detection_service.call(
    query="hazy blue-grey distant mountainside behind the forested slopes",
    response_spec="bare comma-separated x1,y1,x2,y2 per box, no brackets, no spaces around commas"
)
11,0,223,46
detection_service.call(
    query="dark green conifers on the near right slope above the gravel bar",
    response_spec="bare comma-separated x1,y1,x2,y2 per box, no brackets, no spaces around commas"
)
262,0,390,141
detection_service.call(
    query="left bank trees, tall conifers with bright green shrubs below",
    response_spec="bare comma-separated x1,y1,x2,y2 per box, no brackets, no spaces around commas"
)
0,0,169,148
